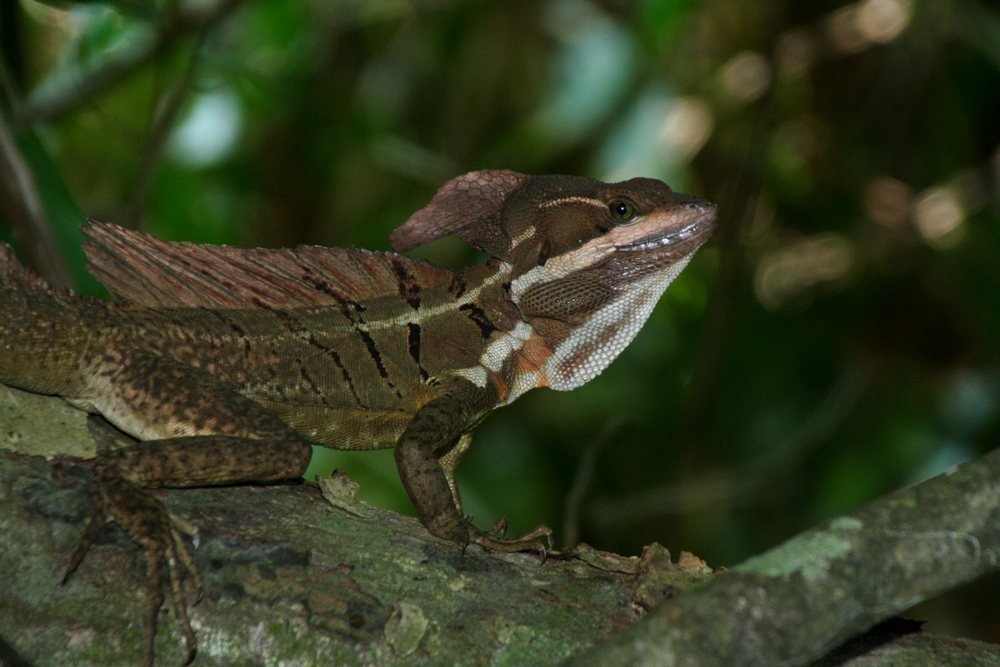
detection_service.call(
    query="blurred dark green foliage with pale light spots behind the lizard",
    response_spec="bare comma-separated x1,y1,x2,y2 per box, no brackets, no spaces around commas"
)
0,0,1000,641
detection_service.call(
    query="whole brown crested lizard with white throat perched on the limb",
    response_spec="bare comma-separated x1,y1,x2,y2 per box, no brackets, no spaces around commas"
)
0,171,716,665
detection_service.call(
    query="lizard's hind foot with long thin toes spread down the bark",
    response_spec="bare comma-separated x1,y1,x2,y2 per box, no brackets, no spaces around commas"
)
62,464,204,667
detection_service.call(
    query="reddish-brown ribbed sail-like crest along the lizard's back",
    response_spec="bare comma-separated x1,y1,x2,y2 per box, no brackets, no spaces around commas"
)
84,219,454,309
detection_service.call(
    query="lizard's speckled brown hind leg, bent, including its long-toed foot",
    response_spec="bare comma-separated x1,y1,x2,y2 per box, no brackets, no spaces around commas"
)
70,349,312,667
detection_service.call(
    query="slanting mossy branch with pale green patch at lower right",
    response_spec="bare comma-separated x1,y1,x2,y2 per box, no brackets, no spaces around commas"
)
567,450,1000,667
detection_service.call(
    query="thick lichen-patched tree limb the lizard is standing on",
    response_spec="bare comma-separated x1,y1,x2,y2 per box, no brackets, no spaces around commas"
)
0,386,711,667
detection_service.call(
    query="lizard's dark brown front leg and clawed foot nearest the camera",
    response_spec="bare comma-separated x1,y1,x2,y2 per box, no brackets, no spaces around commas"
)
395,378,552,555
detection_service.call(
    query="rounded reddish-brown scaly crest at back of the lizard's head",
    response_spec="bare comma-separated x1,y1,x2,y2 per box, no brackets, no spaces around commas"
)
389,169,532,257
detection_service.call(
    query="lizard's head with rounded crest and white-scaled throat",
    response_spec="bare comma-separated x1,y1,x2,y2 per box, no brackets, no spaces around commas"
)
391,171,716,389
